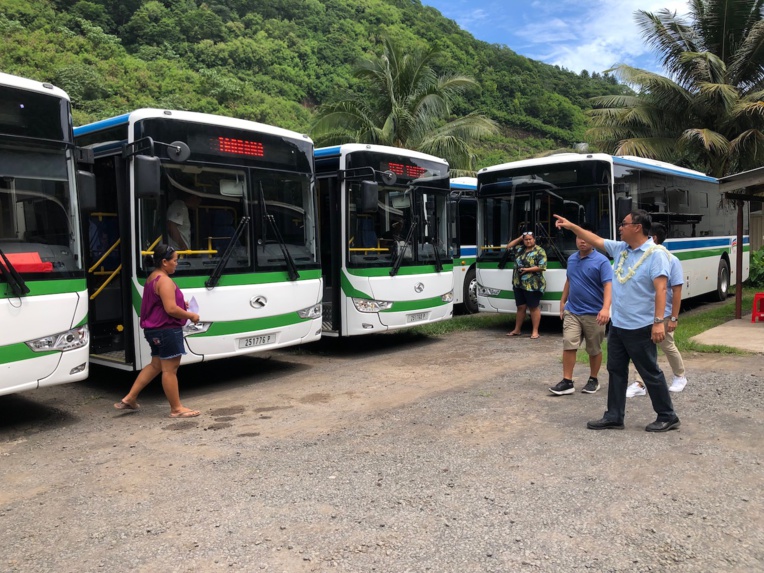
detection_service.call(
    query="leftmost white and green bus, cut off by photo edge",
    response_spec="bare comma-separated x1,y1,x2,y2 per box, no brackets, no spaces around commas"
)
0,73,92,394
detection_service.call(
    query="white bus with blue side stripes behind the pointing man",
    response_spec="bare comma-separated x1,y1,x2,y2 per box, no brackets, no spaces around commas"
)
477,153,750,316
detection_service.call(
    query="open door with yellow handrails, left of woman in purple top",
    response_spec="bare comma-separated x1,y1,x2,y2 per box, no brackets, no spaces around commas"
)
81,155,135,370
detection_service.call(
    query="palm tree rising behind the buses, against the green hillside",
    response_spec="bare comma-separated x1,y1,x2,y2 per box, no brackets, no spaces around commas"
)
311,38,498,174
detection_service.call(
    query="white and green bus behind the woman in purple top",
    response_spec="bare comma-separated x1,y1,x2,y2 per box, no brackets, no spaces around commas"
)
74,109,321,370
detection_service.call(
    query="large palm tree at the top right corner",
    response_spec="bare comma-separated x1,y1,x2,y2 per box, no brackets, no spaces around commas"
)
587,0,764,177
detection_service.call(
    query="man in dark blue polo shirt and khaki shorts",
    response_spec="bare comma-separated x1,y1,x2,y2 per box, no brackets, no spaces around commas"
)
549,223,613,396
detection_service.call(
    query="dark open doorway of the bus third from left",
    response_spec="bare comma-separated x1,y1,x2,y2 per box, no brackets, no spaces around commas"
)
317,177,343,334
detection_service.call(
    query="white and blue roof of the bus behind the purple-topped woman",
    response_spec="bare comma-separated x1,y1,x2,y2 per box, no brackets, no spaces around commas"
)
74,108,312,143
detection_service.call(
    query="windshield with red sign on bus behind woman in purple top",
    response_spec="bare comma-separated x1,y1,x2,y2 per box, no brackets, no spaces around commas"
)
138,119,318,275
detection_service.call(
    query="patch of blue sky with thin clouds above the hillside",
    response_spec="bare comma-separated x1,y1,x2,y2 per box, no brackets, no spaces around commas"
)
421,0,687,73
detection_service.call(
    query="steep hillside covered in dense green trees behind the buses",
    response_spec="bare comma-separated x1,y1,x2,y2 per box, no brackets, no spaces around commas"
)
0,0,625,165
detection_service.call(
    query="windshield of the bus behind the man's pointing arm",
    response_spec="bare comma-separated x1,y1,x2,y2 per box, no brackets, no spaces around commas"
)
478,161,612,263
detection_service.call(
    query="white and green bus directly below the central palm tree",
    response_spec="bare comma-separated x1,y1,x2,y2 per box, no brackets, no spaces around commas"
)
315,144,453,336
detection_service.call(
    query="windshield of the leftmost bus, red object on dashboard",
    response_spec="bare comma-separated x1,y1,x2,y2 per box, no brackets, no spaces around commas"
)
0,142,83,280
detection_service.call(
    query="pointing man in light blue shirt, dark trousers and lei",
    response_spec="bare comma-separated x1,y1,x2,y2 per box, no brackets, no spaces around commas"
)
555,209,680,432
